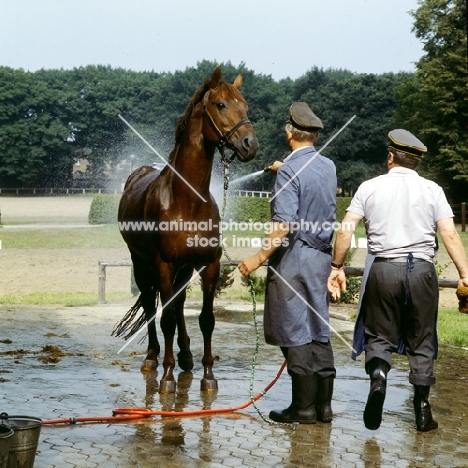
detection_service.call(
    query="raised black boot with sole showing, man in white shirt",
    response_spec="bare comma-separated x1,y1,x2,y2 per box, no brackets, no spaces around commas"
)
364,358,390,431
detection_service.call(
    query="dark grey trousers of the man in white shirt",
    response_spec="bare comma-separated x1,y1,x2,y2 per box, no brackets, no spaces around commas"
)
363,259,439,385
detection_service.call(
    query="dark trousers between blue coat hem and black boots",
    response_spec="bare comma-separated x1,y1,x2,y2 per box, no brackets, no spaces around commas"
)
281,341,336,379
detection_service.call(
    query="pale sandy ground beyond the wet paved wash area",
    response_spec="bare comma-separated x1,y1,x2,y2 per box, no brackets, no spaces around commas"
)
0,196,458,307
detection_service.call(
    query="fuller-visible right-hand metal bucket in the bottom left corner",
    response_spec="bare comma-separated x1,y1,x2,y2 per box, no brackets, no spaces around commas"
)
0,413,42,468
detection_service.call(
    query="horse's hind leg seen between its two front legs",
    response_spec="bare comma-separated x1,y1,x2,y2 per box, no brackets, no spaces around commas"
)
174,267,193,371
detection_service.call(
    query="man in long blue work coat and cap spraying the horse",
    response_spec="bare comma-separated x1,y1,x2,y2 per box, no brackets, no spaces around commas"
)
238,102,336,424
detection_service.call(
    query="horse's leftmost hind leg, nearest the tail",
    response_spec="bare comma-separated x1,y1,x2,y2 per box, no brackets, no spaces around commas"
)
132,252,160,372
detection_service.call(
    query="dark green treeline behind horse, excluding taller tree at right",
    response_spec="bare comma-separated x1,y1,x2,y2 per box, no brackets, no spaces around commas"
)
0,61,408,190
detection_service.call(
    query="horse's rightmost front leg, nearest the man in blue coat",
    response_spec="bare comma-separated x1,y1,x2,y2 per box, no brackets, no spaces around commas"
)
198,261,219,391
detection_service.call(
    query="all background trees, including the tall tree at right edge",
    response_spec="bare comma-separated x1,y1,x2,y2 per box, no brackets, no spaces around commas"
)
0,0,468,203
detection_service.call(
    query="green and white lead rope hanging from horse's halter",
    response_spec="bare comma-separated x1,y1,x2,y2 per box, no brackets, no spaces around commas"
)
220,152,296,431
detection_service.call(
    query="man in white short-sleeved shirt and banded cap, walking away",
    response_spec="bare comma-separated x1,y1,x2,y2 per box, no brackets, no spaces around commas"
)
328,129,468,431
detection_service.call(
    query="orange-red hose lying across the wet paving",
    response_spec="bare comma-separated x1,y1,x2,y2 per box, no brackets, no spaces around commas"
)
42,361,286,425
